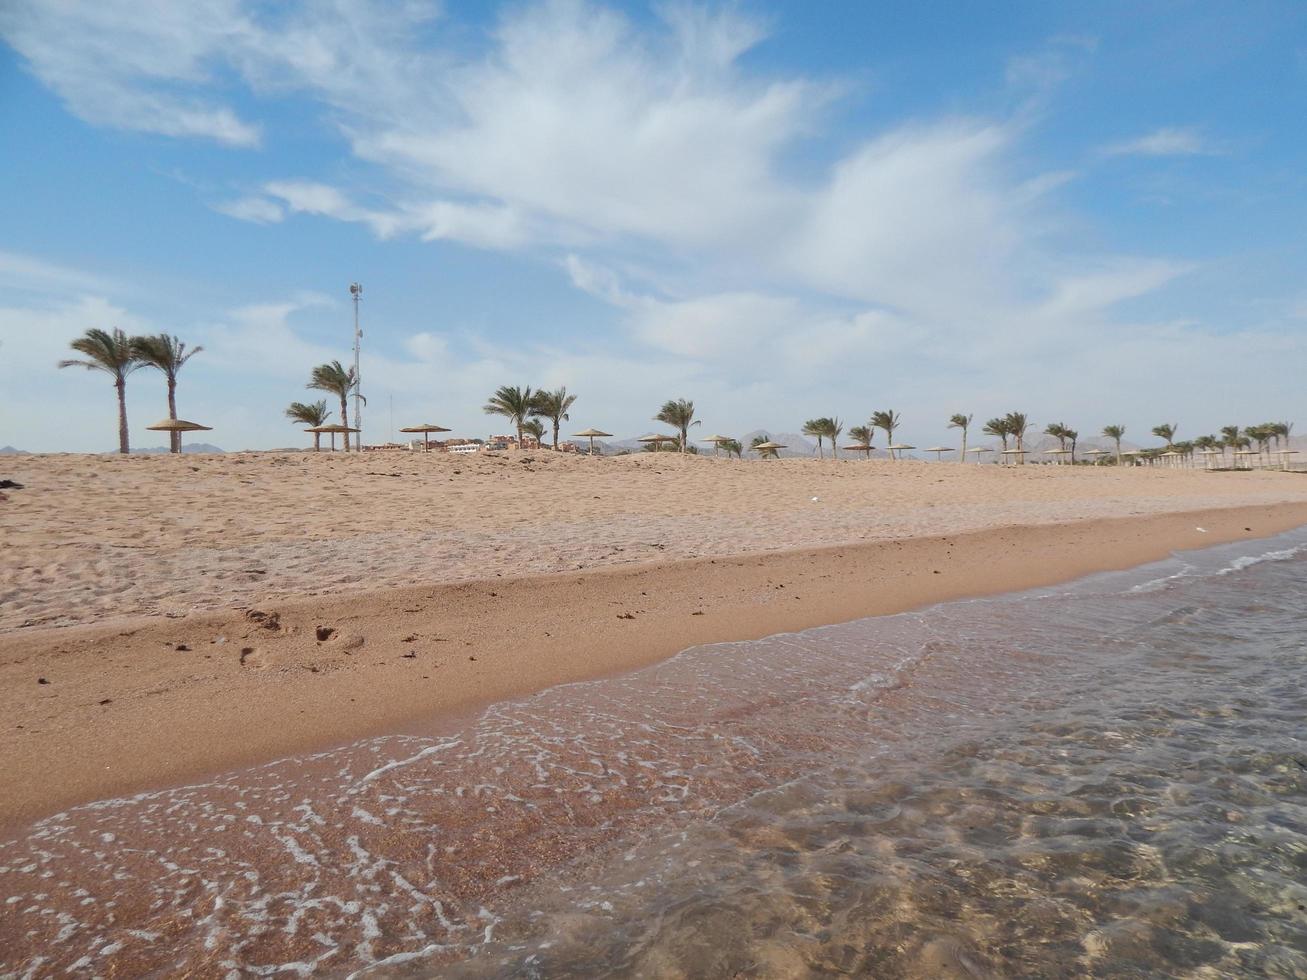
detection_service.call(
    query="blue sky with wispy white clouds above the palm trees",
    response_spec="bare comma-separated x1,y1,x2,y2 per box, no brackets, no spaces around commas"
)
0,0,1307,451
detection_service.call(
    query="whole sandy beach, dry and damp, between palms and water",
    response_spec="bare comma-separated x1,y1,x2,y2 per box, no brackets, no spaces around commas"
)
0,452,1307,823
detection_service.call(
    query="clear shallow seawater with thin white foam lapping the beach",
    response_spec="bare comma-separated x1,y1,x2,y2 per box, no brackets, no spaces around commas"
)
0,529,1307,977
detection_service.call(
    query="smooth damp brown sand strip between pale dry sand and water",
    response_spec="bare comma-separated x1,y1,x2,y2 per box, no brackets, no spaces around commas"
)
0,503,1307,832
